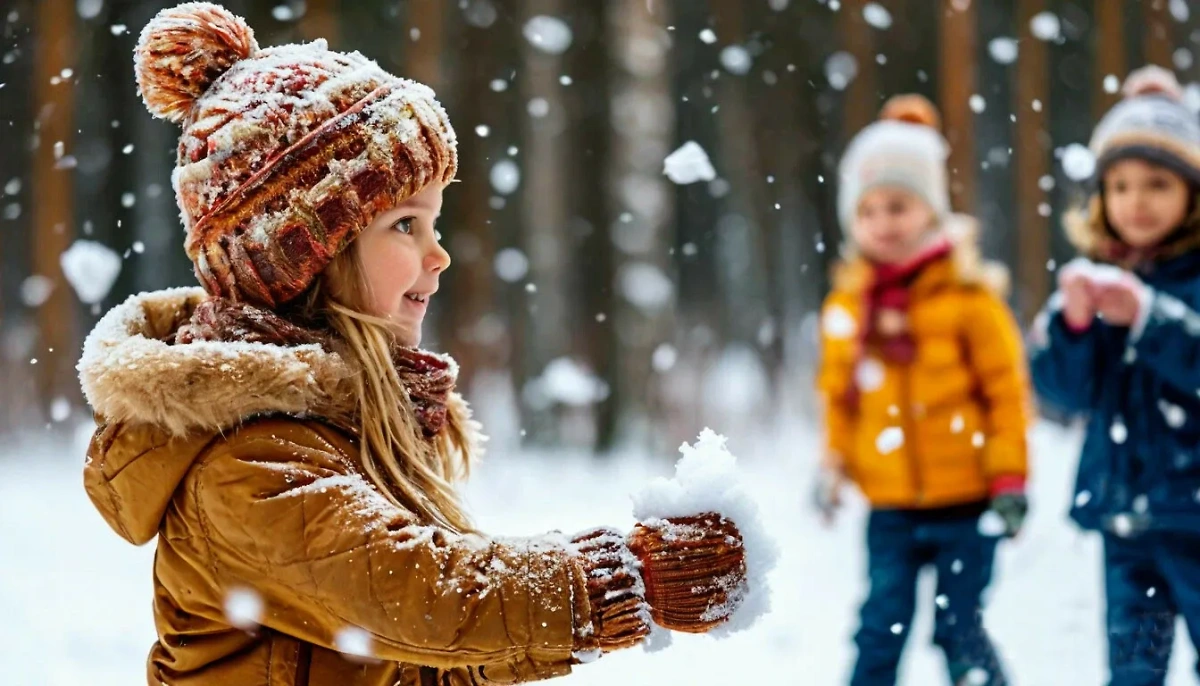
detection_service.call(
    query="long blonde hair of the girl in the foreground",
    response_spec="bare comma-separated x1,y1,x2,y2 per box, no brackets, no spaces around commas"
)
288,243,473,532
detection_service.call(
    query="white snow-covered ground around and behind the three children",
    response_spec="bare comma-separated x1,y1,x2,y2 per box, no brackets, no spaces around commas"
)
0,419,1195,686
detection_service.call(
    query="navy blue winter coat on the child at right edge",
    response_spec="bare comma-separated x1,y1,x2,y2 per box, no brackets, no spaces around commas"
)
1030,251,1200,535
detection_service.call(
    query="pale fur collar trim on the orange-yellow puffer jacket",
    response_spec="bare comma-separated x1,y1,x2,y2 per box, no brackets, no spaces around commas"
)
833,215,1009,296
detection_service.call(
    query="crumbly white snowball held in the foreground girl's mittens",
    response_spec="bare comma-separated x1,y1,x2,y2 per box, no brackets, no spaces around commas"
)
634,428,778,637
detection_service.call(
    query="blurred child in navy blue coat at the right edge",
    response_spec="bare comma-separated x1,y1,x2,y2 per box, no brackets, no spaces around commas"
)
1031,67,1200,686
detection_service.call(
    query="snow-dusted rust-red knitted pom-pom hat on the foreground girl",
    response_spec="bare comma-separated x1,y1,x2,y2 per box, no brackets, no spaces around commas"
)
134,2,457,307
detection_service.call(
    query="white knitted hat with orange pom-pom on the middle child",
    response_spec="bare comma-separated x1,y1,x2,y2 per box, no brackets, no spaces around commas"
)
838,95,950,227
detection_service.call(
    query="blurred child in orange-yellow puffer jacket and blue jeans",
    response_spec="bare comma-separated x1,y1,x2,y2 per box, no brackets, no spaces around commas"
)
818,96,1028,686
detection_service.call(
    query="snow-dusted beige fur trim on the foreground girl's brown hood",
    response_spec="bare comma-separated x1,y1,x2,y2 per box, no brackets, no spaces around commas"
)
77,288,478,443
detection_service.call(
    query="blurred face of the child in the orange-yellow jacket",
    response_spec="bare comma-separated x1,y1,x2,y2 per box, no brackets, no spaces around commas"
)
851,187,936,264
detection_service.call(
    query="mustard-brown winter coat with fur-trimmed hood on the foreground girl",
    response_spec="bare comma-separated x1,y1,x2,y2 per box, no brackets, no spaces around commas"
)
80,289,590,686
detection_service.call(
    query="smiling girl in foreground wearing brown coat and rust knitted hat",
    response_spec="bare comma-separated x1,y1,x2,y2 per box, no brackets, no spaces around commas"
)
79,2,745,686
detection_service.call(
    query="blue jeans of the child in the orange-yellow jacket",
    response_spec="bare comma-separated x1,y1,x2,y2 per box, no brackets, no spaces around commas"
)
851,510,1008,686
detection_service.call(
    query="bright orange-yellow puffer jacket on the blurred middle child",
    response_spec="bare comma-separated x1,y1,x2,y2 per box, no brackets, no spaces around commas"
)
817,229,1030,509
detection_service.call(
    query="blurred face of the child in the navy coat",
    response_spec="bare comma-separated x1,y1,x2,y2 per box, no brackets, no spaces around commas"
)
1104,160,1190,248
